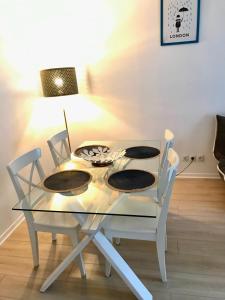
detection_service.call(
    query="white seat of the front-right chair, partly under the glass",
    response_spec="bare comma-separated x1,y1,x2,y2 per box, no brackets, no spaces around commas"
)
104,191,161,239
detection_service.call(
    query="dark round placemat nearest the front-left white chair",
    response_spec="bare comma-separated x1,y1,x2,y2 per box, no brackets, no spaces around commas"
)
42,170,92,195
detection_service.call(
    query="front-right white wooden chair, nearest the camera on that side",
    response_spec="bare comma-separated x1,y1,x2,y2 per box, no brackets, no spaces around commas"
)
104,148,179,282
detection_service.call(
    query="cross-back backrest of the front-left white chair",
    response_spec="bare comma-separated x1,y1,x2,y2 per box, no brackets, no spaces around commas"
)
7,148,45,200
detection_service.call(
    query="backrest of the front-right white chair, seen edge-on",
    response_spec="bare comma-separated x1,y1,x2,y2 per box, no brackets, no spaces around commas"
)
158,148,179,234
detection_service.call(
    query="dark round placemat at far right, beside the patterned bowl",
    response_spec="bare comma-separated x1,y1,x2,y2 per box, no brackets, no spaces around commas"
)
124,146,160,159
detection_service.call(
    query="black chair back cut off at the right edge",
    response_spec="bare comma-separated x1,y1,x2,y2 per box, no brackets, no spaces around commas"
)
213,115,225,160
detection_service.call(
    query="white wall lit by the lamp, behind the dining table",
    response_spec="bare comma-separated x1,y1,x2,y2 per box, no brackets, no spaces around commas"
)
0,0,225,236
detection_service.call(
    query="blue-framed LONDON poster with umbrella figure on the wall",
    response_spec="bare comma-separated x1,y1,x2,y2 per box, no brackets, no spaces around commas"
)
161,0,200,46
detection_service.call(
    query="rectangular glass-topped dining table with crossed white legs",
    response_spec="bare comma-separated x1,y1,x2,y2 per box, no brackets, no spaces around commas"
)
13,140,161,300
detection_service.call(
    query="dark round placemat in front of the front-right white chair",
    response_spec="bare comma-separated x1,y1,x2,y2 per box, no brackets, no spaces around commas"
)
107,169,155,193
